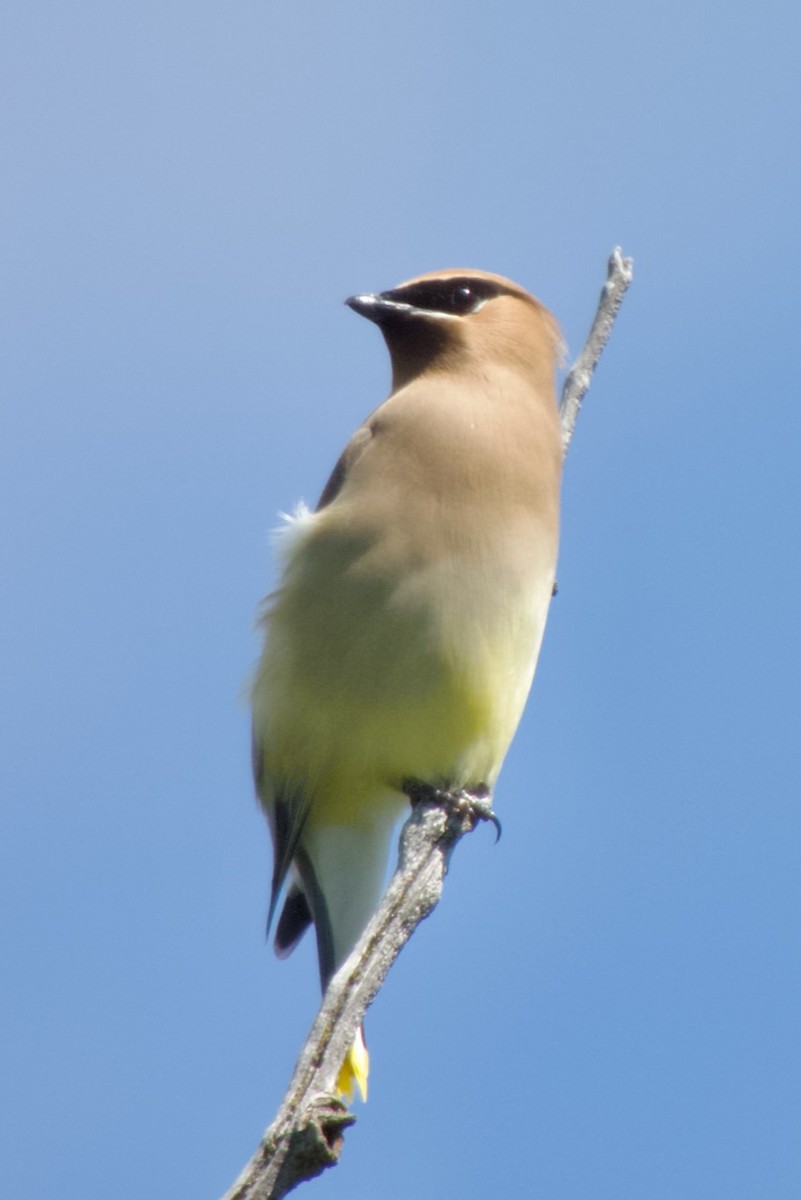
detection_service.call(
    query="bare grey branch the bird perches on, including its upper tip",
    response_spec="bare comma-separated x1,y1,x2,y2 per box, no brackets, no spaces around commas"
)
223,247,632,1200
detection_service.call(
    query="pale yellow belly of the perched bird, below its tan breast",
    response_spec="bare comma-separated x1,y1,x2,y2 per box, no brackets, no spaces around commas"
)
253,530,547,820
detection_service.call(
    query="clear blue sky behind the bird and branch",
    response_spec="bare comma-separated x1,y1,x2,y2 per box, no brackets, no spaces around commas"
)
0,0,801,1200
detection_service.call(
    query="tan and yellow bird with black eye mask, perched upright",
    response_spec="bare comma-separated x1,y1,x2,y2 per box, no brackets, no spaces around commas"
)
251,269,562,1099
